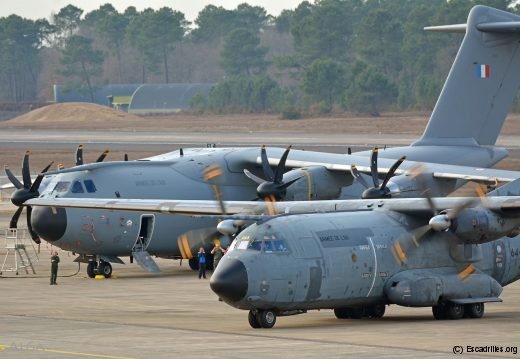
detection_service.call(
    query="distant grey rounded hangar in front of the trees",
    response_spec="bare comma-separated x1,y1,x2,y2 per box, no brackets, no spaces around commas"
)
54,83,215,114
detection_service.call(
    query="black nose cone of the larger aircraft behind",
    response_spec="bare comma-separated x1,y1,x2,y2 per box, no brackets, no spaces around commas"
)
31,207,67,242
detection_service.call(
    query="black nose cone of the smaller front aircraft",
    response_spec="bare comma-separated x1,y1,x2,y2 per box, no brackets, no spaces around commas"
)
209,259,247,302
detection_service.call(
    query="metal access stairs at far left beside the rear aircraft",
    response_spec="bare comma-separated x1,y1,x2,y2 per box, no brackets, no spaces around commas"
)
0,228,38,275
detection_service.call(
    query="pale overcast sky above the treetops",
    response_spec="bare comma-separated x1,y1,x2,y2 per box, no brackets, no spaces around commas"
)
0,0,303,21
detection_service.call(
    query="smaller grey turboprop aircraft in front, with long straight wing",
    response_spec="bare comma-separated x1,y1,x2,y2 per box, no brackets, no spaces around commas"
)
28,172,520,328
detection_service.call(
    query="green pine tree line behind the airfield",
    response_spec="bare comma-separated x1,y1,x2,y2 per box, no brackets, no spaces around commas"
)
0,0,519,118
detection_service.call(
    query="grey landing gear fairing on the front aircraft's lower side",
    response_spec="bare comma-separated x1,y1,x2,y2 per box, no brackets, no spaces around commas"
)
384,269,502,307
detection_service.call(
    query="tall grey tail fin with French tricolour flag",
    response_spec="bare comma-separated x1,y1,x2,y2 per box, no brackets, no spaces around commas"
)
413,5,520,146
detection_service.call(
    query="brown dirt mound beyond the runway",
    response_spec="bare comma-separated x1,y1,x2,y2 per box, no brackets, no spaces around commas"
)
6,102,140,127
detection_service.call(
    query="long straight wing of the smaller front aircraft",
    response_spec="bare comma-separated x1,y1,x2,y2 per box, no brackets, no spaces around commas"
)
25,196,520,219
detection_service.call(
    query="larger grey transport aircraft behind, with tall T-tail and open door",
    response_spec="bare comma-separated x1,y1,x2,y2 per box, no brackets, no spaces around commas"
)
7,7,520,276
